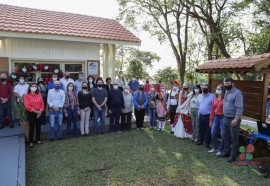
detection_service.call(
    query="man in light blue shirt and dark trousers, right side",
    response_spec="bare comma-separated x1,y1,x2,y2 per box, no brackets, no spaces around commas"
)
195,83,214,149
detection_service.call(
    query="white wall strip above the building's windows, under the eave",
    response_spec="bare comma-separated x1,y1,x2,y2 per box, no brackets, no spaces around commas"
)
0,38,100,61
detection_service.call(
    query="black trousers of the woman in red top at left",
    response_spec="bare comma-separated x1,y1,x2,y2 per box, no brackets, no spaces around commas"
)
28,112,41,143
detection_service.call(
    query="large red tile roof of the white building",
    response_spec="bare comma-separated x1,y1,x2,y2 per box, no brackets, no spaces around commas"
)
0,4,141,43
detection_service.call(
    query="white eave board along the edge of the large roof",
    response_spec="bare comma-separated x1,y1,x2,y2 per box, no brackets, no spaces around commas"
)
0,31,141,46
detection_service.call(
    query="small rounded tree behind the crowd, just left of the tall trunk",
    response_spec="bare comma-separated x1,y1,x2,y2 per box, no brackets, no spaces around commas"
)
154,67,179,86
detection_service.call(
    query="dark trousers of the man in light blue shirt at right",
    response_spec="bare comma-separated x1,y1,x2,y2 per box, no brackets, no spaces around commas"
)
199,114,211,147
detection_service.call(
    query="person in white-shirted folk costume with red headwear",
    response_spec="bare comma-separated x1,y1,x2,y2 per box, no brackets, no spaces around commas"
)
167,80,179,134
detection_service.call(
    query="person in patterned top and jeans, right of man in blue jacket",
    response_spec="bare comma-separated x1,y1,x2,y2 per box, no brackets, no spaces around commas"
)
148,85,157,128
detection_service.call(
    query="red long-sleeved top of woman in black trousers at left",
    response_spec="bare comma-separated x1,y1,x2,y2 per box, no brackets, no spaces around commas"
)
24,93,44,112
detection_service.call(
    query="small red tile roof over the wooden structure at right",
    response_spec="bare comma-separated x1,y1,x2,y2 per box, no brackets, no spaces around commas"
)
196,53,270,73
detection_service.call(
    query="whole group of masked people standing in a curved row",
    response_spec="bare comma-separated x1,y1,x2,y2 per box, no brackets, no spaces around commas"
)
0,71,243,162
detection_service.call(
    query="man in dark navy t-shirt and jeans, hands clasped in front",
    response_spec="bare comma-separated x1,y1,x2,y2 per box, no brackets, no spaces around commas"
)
91,78,108,134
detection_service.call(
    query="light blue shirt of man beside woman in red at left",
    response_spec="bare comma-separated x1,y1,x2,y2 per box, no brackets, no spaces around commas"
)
47,89,65,108
